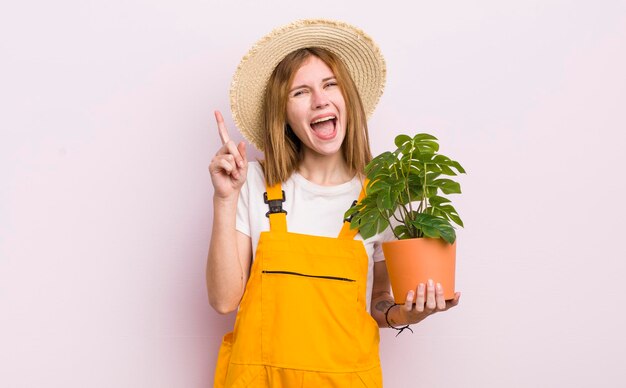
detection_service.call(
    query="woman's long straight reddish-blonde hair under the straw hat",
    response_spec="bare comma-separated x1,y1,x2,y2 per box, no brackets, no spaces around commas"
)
261,47,372,185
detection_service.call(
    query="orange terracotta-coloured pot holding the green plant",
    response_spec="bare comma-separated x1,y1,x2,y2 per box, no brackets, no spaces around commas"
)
383,238,456,304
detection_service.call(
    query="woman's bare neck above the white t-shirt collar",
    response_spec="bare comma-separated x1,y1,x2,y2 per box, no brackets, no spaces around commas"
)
298,152,353,186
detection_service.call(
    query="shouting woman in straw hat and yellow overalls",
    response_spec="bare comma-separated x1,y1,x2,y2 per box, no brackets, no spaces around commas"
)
207,20,459,387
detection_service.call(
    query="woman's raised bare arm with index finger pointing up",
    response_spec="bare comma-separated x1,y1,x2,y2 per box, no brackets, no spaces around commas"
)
206,112,252,314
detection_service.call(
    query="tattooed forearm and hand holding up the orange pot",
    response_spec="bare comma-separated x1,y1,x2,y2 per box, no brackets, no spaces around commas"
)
371,261,461,327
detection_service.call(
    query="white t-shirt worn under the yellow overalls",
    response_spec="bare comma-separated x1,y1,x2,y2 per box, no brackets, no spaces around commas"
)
236,162,393,311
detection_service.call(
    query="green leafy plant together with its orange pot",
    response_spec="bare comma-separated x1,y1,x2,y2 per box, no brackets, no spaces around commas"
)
346,133,465,304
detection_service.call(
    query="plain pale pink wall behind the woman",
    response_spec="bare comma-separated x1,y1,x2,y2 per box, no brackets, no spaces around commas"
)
0,0,626,388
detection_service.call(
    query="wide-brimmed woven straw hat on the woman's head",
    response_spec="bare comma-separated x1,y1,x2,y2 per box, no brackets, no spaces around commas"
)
230,19,386,150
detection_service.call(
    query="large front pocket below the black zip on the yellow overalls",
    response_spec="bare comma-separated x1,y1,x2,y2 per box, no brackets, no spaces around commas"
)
261,269,359,372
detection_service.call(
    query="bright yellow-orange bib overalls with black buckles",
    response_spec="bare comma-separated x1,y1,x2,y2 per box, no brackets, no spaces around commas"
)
214,183,382,388
